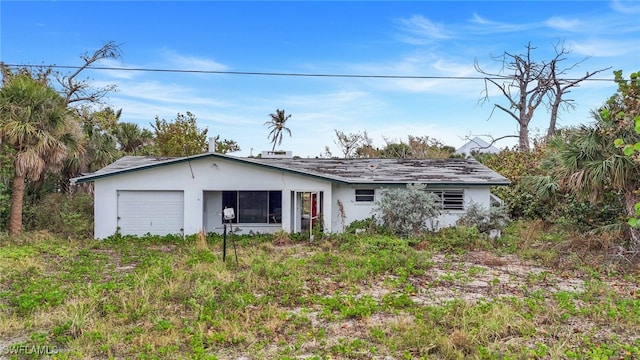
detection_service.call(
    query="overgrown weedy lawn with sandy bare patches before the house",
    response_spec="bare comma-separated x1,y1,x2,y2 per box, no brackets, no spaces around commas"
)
0,223,640,359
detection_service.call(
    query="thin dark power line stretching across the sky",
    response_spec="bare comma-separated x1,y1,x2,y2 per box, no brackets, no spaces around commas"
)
4,64,614,81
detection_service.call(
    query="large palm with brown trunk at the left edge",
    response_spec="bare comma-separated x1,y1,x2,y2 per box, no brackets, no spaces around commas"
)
0,74,83,235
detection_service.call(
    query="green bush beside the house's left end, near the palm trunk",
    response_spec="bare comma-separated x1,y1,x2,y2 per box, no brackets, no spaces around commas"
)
25,193,93,238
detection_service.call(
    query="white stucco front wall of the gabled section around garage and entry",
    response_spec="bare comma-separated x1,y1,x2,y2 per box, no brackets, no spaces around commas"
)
94,158,332,239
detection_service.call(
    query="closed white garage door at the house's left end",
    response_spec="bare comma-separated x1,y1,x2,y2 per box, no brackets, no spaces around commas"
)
118,191,184,236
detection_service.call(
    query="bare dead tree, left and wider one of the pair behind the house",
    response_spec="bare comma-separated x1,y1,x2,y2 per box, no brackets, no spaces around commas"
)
474,43,550,151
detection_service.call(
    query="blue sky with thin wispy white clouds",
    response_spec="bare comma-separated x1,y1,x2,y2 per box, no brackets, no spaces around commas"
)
0,0,640,157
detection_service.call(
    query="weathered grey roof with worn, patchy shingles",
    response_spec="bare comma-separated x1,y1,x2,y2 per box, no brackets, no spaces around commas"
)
71,153,509,185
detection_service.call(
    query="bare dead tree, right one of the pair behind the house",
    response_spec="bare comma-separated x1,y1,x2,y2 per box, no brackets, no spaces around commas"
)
546,40,611,141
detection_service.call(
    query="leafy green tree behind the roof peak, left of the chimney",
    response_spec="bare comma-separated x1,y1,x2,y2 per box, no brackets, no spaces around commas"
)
151,111,208,156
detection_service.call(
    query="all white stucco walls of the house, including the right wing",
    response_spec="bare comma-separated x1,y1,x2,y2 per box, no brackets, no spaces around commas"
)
94,157,490,239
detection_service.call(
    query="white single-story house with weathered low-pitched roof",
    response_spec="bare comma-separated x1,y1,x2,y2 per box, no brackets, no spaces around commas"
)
72,148,509,239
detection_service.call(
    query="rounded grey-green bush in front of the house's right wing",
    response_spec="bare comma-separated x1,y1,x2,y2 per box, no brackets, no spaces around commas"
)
376,185,440,237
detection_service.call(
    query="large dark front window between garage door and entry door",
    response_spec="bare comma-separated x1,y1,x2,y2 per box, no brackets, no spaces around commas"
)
222,191,282,224
